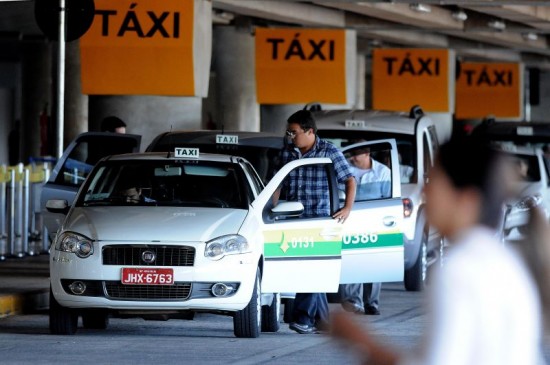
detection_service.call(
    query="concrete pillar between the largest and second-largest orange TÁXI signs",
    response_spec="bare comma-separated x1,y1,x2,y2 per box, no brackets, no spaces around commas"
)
212,26,260,131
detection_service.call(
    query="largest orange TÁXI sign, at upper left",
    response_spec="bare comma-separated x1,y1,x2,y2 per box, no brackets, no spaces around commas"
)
80,0,211,96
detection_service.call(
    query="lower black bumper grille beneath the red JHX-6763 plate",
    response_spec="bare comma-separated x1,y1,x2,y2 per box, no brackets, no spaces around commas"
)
105,281,191,300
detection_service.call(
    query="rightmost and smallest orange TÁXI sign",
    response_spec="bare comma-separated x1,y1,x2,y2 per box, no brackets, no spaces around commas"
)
456,62,523,119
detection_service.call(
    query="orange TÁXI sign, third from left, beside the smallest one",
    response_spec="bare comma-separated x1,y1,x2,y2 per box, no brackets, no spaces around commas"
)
372,49,454,113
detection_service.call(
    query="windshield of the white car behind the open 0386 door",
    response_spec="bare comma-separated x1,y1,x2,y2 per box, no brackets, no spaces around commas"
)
317,129,417,184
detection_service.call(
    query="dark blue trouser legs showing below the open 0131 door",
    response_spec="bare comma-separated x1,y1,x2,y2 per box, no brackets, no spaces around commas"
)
292,293,329,326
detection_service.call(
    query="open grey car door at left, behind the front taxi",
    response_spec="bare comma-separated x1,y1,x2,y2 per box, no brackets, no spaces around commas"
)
40,132,141,239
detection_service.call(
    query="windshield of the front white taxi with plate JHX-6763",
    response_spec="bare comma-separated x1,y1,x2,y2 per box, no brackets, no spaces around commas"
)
76,160,250,209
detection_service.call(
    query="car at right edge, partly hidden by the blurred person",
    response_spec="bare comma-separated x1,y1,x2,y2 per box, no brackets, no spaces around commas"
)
472,118,550,241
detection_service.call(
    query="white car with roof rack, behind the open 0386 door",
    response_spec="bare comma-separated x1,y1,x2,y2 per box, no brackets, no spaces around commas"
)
312,104,444,291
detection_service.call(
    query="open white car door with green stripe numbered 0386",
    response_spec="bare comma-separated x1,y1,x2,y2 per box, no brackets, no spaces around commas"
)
340,139,405,284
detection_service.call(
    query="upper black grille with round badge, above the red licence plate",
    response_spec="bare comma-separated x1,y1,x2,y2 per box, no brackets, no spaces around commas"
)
102,245,195,266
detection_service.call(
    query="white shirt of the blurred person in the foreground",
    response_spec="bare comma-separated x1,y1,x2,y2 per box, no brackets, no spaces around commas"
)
402,227,542,365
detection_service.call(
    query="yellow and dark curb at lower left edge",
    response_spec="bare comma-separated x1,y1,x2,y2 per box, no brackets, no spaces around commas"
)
0,290,50,318
